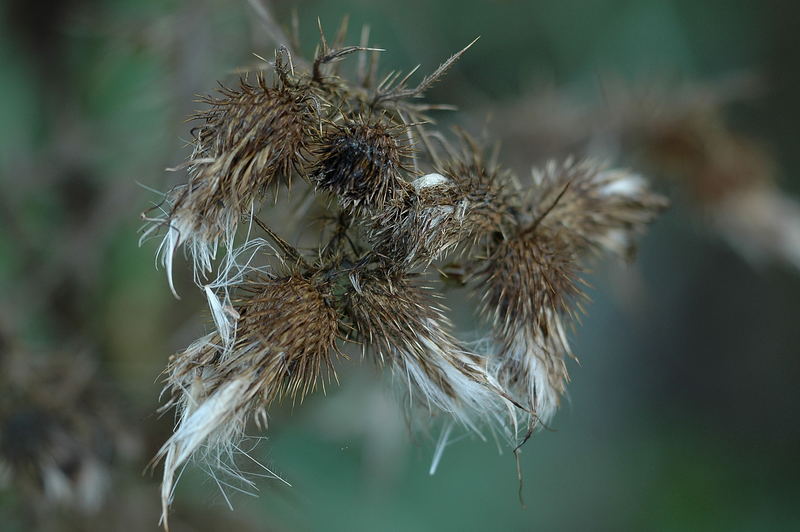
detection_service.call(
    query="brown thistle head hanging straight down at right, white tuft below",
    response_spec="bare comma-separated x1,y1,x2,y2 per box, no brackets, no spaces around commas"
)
474,226,581,422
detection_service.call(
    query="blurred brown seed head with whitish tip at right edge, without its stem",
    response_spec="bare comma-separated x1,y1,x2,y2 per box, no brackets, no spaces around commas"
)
629,92,800,269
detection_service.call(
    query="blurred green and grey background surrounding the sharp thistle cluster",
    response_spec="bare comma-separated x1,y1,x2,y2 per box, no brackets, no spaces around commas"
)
0,0,800,531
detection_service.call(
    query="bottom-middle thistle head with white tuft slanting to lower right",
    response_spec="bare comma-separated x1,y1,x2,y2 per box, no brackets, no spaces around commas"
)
344,272,509,431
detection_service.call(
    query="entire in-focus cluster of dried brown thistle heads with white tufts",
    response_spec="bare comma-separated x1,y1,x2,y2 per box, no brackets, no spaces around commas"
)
143,17,666,526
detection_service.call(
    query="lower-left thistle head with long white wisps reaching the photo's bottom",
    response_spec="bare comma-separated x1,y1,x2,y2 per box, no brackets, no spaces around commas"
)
158,273,338,519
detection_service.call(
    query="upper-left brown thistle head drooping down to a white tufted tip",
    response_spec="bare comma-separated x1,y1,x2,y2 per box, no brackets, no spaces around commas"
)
145,75,317,291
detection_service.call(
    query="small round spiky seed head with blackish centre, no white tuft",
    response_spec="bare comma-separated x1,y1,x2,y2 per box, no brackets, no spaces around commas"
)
311,115,412,212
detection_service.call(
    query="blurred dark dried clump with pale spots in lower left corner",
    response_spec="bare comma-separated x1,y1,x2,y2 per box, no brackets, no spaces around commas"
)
0,348,138,516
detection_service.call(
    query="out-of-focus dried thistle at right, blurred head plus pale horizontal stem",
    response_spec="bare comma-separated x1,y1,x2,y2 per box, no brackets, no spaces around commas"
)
492,74,800,269
